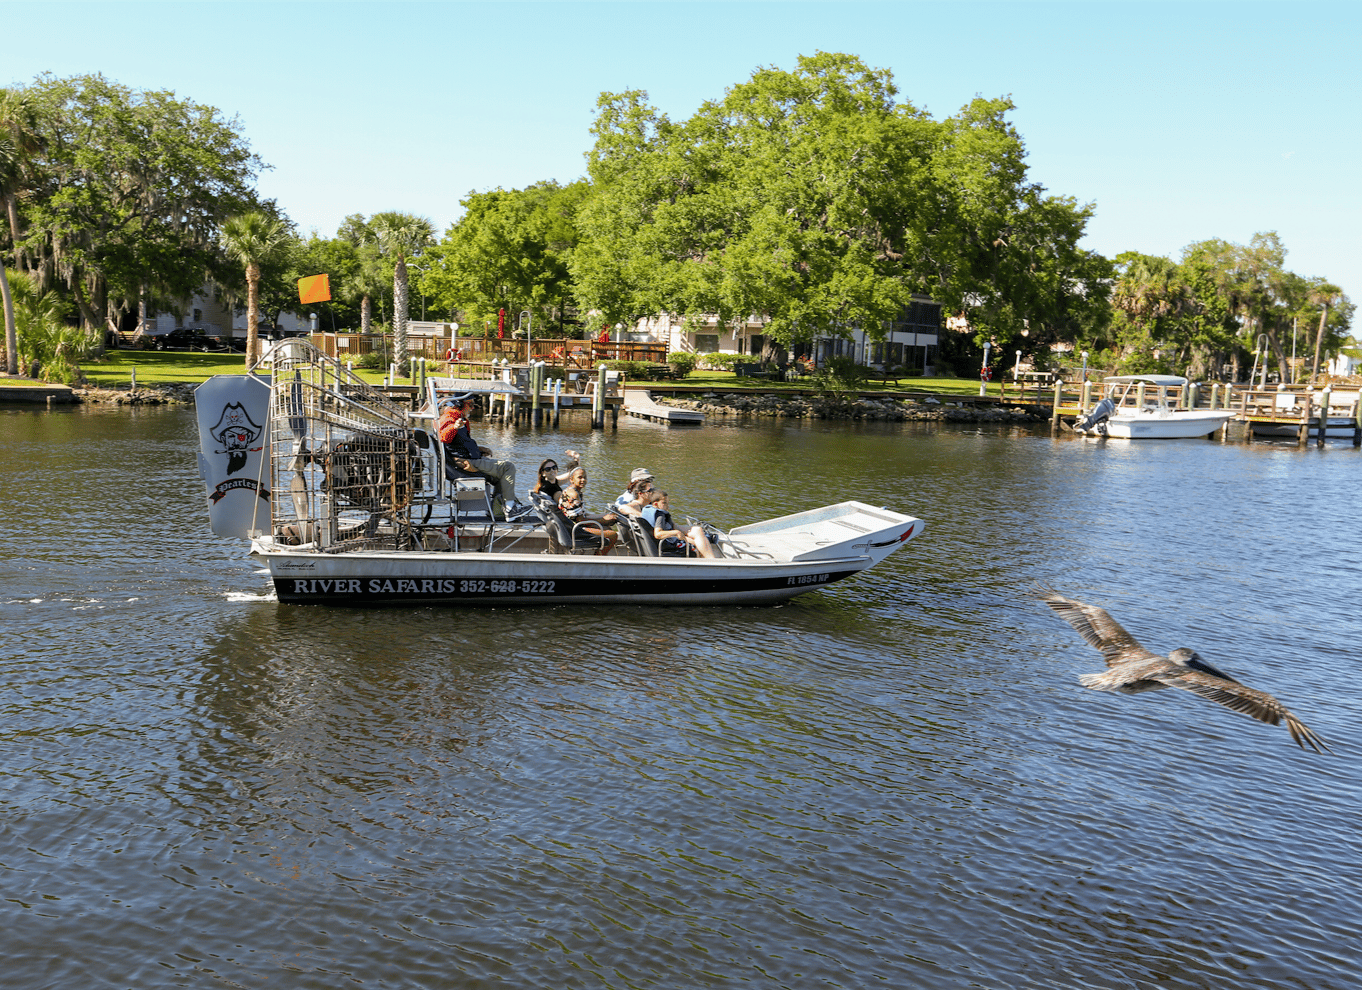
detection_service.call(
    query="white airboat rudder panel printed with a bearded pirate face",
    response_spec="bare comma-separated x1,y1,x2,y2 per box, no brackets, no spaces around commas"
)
193,374,270,538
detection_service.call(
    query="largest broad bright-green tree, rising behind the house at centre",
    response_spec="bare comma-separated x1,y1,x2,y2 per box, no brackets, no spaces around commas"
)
572,53,1110,343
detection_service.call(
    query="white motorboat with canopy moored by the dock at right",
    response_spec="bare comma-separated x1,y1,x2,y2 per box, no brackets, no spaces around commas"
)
1073,374,1234,440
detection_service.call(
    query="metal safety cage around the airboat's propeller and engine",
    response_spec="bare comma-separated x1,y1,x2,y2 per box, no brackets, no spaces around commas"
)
268,339,429,553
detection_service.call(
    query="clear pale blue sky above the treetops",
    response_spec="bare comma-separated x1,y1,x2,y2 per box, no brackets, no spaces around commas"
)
0,0,1362,301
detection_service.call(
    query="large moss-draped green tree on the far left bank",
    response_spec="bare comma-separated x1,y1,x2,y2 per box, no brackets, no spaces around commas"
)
18,75,262,348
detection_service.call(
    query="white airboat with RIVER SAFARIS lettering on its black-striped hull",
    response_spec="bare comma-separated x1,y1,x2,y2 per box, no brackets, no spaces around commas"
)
195,340,923,605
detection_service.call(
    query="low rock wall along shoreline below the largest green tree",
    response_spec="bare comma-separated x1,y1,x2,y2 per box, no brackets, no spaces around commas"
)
654,392,1050,424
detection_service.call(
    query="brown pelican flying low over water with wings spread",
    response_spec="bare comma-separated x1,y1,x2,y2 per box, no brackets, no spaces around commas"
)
1035,584,1333,753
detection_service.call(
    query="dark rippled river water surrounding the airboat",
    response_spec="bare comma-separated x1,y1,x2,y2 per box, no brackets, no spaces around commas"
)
0,409,1362,990
